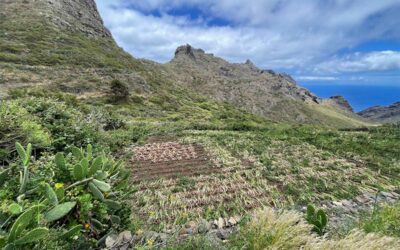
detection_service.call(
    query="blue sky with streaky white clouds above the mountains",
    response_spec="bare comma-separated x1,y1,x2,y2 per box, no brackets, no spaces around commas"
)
96,0,400,110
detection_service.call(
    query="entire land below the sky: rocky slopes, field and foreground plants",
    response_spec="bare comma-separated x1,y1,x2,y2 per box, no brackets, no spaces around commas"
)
0,0,400,250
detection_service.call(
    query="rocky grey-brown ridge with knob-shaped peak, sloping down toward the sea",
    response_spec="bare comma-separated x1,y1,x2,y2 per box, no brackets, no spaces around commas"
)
167,45,368,125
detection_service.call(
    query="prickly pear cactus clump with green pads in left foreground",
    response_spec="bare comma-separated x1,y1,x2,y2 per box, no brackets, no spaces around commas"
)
0,143,129,249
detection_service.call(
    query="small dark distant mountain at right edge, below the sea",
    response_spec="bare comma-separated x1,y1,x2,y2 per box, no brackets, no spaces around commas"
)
358,102,400,123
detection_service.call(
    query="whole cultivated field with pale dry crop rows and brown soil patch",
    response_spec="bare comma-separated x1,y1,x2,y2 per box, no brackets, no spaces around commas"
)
133,131,393,226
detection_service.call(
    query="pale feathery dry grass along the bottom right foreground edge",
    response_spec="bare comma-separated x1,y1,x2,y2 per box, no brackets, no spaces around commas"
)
231,208,400,250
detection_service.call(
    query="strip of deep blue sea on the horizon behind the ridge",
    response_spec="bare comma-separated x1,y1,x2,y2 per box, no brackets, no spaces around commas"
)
300,83,400,112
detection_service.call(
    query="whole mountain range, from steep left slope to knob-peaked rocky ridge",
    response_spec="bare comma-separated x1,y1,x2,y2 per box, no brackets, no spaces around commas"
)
0,0,364,127
